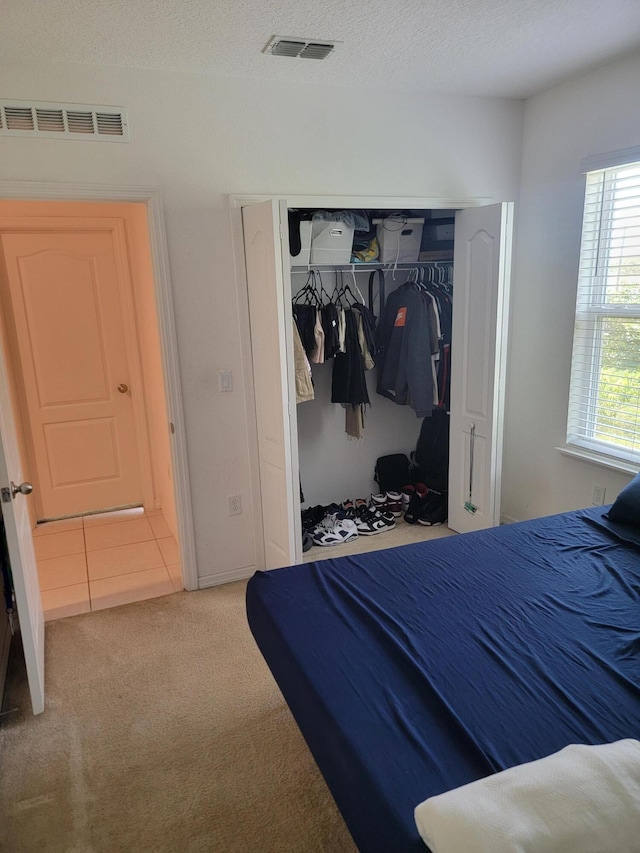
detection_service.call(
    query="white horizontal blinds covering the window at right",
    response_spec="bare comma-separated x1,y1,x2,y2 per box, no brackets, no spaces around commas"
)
567,162,640,464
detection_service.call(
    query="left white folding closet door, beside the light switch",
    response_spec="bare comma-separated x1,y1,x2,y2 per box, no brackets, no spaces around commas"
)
242,201,301,569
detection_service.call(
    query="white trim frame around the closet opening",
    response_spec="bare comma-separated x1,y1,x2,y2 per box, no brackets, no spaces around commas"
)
228,192,498,569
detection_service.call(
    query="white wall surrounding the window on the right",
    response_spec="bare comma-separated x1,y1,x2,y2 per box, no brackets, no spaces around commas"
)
502,51,640,519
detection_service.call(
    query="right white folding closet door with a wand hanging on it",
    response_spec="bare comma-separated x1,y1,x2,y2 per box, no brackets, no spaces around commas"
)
448,202,513,533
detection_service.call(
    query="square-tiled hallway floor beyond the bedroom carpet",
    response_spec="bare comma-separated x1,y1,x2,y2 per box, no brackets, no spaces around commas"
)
33,507,182,621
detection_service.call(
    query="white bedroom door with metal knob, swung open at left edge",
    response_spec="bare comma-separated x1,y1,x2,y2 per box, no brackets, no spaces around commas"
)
0,346,44,714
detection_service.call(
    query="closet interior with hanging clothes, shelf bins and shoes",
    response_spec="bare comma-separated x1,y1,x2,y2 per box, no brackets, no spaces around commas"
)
288,209,455,559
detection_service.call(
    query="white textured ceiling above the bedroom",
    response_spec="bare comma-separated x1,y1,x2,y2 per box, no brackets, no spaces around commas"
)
0,0,640,97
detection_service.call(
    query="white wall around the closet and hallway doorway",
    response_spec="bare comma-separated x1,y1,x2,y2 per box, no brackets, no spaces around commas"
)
0,62,523,584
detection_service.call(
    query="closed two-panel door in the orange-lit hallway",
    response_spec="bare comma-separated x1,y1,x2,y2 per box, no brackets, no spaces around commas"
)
0,228,144,520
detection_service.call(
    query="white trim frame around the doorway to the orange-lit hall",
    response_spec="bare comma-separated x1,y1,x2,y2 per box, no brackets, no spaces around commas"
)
0,181,199,590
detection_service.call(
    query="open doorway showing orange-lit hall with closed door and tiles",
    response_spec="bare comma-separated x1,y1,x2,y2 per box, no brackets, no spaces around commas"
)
0,201,184,619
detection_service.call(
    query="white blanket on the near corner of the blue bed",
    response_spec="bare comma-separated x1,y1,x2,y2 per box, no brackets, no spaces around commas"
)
415,740,640,853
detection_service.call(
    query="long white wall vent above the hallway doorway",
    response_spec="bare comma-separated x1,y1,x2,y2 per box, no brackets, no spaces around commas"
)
0,99,129,142
